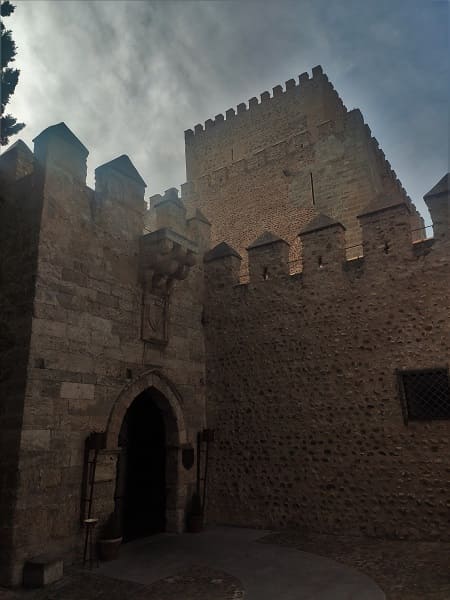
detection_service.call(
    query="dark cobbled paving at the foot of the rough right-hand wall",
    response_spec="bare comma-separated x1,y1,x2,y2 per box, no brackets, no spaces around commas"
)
261,531,450,600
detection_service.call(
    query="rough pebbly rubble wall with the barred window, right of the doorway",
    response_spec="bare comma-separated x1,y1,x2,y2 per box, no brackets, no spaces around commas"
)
205,205,450,539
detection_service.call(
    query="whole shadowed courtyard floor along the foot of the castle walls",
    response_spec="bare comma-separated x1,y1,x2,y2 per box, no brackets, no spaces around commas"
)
0,527,450,600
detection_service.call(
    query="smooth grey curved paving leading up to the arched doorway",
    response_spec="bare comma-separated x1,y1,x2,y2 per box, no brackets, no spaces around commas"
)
83,527,385,600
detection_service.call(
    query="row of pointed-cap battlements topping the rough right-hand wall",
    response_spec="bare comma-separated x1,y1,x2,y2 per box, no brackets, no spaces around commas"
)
205,196,450,287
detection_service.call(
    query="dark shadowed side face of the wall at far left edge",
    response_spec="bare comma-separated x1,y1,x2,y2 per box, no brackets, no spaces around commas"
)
0,142,40,581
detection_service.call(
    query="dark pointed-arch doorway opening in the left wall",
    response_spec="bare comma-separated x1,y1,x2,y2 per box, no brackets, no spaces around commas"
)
116,388,167,542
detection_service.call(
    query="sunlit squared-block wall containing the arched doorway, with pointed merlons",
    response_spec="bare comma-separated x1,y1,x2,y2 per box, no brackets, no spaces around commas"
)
0,124,206,583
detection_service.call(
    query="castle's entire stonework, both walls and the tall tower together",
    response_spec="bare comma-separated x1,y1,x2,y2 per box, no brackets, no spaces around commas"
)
0,69,450,583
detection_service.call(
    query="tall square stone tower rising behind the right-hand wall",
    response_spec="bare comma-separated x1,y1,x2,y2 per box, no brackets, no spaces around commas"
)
182,67,423,273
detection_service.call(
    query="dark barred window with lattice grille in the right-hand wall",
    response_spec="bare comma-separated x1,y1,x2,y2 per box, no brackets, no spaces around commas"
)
397,367,450,422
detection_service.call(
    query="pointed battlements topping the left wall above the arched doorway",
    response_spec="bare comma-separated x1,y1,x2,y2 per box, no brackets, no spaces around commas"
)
0,123,209,251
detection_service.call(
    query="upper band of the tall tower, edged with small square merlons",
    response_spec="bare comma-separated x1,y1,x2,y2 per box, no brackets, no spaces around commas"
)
185,66,347,181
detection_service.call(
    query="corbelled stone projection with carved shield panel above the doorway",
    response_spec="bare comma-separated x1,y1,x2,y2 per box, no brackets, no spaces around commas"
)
139,228,197,346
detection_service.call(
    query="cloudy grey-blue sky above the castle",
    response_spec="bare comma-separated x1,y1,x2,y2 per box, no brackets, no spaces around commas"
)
6,0,449,225
